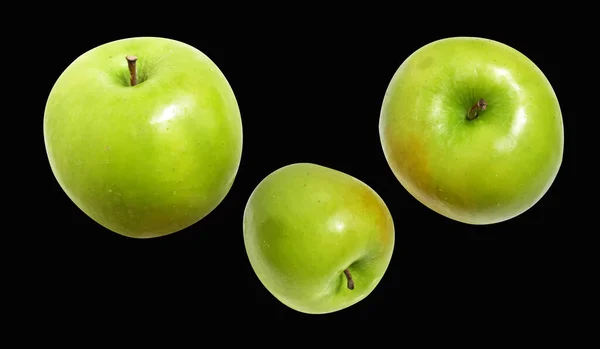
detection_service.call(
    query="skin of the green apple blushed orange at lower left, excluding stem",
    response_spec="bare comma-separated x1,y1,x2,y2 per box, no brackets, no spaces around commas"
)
379,37,564,225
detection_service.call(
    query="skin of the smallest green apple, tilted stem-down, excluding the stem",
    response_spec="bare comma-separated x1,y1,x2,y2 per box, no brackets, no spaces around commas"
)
243,163,394,314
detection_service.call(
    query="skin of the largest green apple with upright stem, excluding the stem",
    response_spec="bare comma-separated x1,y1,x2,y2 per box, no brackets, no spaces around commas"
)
43,37,242,238
